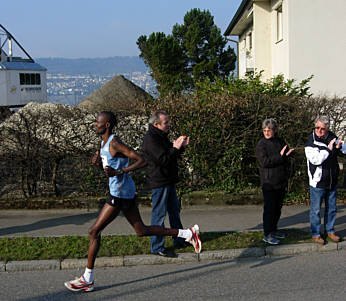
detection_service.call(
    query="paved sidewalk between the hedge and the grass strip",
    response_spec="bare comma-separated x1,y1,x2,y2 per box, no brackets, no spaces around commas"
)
0,204,346,237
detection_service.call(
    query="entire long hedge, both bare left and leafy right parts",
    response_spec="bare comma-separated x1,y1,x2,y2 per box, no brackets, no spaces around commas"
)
0,74,345,199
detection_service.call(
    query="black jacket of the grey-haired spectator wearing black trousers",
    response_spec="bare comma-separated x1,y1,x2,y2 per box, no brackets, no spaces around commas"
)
256,136,289,190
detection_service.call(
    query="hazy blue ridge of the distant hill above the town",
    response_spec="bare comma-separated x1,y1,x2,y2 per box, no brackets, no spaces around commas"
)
35,56,148,75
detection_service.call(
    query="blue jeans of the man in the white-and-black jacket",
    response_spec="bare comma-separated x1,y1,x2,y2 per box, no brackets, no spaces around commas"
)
310,186,337,237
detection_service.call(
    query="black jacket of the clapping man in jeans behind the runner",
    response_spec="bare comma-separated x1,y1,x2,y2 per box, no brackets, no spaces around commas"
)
142,124,182,189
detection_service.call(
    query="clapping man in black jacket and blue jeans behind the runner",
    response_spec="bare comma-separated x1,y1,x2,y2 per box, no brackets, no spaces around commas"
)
142,110,189,257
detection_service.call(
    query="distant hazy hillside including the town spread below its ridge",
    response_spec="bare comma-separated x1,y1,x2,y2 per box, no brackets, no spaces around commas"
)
36,56,156,105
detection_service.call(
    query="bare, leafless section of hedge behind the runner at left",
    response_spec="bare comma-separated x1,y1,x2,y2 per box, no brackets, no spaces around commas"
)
0,103,146,198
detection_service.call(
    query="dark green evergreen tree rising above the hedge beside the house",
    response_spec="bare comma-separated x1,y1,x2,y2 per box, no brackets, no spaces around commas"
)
137,8,236,94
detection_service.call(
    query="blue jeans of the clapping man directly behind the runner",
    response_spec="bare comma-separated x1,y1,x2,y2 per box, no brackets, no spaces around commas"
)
150,185,184,254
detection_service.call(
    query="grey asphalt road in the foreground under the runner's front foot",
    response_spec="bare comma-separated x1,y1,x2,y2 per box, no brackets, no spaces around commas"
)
0,250,346,301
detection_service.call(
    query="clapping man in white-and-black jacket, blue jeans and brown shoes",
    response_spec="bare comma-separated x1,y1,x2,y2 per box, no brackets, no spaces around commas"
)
305,116,342,245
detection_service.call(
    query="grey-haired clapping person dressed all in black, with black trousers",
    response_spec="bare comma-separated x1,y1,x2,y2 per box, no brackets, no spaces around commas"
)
256,118,294,245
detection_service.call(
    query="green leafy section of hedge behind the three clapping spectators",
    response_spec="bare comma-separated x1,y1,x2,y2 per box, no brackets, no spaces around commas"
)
137,74,344,192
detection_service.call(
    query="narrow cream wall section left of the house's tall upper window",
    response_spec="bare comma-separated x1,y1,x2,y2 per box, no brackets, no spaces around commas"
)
253,1,272,80
